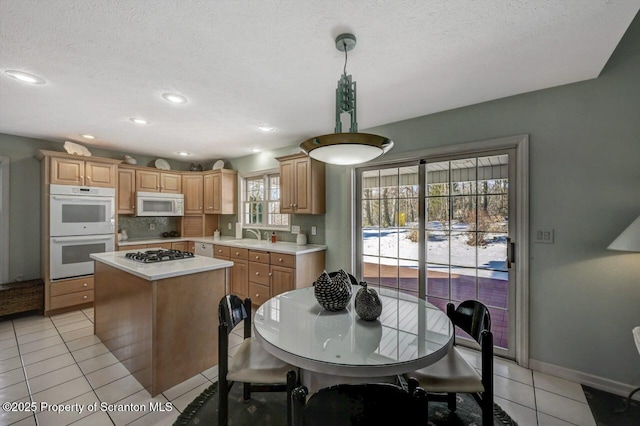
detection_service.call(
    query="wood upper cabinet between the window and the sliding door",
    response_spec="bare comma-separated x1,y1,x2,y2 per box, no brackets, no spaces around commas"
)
276,154,325,214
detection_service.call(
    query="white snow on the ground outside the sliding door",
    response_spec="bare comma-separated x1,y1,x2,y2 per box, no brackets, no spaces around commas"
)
362,228,508,280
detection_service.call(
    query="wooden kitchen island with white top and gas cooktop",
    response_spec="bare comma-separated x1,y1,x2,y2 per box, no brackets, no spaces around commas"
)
91,251,233,396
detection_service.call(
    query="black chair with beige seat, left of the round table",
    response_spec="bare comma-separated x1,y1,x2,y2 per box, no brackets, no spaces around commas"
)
218,294,297,426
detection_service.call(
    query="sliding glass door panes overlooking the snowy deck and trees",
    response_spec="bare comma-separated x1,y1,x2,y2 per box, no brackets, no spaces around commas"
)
356,150,515,357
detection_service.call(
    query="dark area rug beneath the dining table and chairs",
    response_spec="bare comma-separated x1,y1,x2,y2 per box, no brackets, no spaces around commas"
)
174,383,516,426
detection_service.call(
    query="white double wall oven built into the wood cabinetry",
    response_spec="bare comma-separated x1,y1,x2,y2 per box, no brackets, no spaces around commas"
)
49,184,115,280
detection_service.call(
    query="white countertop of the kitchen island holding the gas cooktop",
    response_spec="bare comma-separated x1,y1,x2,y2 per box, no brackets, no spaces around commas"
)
91,250,233,281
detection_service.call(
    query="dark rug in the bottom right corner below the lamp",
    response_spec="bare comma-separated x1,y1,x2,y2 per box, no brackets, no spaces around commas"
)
582,385,640,426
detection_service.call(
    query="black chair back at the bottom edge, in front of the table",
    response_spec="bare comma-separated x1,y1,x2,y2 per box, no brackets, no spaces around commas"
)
292,379,428,426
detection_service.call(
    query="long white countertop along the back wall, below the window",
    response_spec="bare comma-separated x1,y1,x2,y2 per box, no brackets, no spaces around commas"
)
118,236,327,255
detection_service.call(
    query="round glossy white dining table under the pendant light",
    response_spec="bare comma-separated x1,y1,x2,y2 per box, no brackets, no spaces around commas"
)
254,286,454,382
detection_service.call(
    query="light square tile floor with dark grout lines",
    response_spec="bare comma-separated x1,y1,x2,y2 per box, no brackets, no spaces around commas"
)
0,309,595,426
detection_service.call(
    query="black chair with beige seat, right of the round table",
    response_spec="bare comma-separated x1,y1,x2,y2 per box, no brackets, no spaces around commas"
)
409,300,493,425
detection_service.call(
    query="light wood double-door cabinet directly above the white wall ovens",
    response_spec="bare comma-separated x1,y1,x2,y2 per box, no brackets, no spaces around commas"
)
49,157,119,188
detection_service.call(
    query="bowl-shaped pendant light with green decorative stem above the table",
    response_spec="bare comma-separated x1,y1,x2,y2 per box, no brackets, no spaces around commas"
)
300,34,393,165
